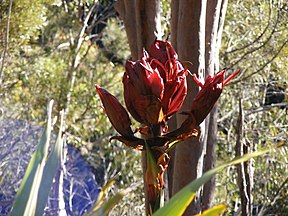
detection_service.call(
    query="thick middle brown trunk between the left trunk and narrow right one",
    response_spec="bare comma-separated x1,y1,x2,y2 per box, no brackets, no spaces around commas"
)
171,0,206,215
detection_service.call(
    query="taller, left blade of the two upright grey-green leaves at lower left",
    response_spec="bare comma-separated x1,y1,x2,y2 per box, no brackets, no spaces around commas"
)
10,100,53,216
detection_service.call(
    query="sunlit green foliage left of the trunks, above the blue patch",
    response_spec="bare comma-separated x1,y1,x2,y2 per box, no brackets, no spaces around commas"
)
0,1,143,214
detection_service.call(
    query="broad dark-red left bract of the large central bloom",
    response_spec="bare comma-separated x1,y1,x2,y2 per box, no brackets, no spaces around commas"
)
123,51,164,124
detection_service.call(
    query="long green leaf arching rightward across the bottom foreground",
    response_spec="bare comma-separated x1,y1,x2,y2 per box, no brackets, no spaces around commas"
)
153,145,279,216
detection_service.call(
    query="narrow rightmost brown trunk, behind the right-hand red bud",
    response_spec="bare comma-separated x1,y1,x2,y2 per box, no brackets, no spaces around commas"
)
202,0,222,210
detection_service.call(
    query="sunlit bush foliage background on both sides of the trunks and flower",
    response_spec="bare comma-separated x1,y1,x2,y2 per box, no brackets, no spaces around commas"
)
0,0,288,215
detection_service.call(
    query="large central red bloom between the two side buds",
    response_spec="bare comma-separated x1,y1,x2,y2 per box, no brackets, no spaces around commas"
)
123,40,187,125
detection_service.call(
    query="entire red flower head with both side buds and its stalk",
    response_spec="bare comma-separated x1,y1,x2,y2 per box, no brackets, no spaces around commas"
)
96,40,239,207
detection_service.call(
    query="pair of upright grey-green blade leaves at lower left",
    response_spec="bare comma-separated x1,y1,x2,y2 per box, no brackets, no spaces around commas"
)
11,101,64,215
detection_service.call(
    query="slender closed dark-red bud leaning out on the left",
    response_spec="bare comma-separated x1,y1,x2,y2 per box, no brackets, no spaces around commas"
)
95,85,134,139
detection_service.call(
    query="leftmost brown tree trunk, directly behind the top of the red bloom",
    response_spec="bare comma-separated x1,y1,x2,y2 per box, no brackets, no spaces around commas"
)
115,0,161,215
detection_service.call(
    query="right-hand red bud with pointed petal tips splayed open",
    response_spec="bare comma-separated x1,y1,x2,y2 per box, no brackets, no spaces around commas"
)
191,69,240,125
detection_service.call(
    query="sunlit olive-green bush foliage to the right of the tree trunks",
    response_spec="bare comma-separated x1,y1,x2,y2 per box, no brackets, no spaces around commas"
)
216,1,288,214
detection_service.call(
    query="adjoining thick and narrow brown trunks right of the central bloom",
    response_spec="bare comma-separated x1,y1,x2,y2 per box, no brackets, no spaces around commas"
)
169,0,227,215
